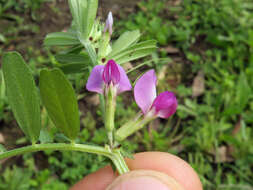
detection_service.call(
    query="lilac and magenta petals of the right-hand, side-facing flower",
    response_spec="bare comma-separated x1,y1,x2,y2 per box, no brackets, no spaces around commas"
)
134,70,177,118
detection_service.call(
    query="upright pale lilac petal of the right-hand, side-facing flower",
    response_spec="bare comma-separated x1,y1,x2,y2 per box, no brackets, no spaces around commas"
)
134,69,157,114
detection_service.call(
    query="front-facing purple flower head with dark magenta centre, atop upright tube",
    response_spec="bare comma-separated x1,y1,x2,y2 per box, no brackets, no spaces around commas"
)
86,60,132,94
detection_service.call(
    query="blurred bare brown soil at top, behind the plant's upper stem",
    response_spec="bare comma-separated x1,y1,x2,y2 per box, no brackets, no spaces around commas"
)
0,0,139,54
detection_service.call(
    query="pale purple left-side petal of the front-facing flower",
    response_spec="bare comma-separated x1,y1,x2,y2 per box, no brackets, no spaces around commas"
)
86,65,105,94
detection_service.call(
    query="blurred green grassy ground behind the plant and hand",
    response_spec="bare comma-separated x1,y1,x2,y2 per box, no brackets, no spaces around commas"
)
0,0,253,190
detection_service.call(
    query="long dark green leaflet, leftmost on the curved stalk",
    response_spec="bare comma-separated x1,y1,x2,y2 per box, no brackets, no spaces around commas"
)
3,52,41,143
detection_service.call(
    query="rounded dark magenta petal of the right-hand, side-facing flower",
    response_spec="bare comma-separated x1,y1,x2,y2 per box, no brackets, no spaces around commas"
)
152,91,177,118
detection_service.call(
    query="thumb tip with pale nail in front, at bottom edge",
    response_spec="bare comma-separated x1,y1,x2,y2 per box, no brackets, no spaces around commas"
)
107,170,183,190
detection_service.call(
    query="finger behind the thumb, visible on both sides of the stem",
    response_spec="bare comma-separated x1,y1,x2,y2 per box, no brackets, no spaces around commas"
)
70,152,202,190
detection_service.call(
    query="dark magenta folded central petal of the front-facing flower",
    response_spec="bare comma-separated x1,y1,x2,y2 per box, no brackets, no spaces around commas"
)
103,60,120,85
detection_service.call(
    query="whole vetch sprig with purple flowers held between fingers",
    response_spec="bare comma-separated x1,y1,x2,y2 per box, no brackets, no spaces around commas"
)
0,0,177,174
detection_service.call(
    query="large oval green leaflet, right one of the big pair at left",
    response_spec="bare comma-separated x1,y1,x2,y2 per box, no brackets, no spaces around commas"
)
39,69,80,140
